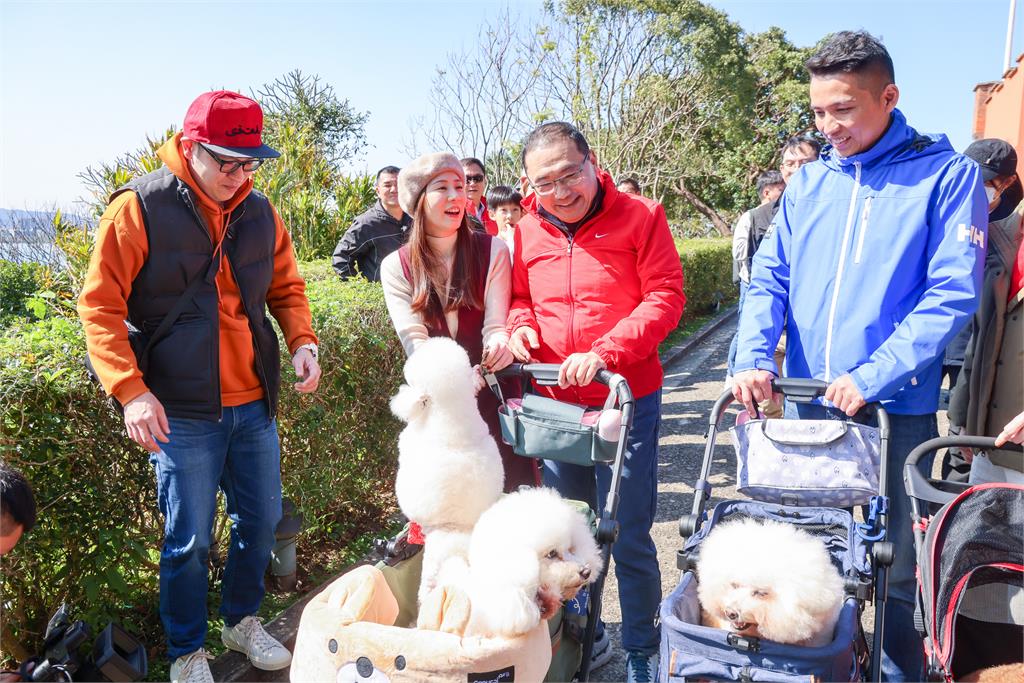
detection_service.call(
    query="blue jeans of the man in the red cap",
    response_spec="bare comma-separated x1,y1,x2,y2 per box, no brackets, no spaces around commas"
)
150,400,281,660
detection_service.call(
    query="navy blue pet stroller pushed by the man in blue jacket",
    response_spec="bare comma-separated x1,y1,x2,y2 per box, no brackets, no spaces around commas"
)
658,379,892,683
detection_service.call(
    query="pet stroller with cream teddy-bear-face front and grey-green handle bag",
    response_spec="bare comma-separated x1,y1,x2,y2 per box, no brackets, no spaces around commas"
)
291,365,634,683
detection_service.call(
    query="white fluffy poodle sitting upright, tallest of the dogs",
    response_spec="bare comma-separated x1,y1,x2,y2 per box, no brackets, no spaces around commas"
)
391,337,505,603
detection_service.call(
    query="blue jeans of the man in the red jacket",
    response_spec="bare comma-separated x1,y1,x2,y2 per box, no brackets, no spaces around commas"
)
544,389,662,654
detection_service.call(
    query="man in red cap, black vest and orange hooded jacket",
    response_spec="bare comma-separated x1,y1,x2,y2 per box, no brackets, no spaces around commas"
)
78,90,321,682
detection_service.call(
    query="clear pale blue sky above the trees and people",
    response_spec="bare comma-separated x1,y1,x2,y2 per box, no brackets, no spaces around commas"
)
0,0,1024,209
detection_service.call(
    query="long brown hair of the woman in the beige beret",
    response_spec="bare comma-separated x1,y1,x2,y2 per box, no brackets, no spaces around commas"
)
409,191,484,327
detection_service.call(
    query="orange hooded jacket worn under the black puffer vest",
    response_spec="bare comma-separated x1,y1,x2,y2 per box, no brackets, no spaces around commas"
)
78,133,316,407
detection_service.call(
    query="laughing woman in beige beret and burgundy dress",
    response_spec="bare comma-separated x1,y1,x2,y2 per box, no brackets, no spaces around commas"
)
381,152,540,492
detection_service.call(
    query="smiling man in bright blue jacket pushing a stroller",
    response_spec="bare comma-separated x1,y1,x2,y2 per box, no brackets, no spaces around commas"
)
734,31,987,681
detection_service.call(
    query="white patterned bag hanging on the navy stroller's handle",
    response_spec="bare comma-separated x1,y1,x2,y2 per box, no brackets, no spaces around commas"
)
729,420,881,508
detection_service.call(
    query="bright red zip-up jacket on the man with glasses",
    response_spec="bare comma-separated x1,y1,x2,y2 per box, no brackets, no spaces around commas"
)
507,172,686,405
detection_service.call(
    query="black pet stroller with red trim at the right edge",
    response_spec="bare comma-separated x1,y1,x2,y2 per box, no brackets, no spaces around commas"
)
903,436,1024,681
